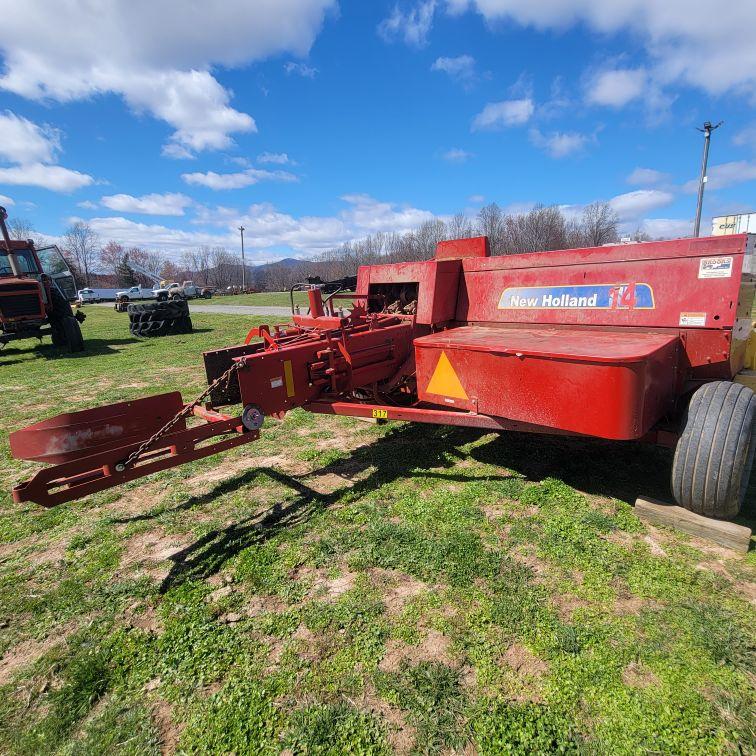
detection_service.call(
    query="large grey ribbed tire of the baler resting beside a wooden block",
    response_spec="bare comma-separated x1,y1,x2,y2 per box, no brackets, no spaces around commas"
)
672,381,756,520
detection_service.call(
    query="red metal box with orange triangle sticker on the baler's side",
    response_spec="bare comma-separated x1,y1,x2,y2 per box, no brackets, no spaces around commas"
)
415,326,679,439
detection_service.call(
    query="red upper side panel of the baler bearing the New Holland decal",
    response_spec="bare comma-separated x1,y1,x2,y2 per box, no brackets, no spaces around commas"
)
457,235,748,330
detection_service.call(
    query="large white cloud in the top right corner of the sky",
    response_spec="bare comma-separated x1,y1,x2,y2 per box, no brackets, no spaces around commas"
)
450,0,756,96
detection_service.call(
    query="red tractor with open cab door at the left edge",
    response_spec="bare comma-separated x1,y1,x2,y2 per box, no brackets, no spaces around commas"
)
0,207,86,352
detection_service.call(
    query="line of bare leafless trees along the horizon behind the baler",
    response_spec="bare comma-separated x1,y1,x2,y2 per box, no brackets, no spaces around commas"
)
9,202,649,291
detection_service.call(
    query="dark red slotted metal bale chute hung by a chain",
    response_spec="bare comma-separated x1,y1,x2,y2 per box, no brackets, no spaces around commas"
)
10,391,259,507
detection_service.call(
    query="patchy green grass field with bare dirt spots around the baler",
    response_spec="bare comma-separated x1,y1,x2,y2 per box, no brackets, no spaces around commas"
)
0,308,756,754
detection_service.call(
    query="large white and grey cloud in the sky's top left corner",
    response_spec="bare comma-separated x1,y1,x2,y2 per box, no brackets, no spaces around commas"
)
0,0,335,157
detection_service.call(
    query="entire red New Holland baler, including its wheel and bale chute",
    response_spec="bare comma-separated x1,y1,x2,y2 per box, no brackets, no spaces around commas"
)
10,235,756,518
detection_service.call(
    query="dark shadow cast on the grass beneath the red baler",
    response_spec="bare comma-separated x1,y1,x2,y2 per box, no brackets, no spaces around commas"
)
108,424,692,592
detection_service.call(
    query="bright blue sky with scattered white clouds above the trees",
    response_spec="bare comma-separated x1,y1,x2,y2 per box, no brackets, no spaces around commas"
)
0,0,756,261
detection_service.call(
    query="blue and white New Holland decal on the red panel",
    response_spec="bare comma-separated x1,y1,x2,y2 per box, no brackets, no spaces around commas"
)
499,283,655,310
